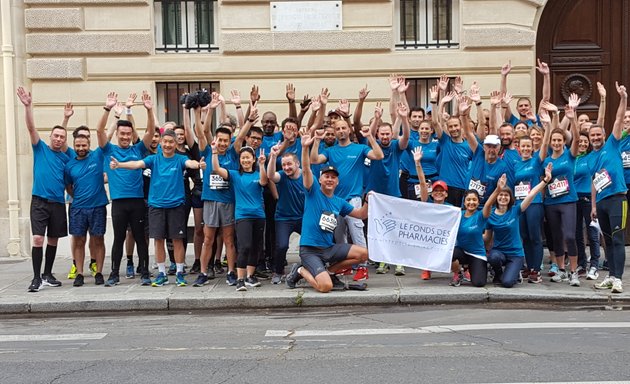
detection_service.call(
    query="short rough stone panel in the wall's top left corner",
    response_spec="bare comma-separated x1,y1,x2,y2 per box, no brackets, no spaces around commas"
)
24,8,83,30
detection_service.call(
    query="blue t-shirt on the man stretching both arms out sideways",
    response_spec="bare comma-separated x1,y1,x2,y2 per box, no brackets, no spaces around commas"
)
143,153,188,208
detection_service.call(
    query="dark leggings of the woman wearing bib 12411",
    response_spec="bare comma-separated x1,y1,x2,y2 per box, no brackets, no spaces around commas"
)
545,203,577,258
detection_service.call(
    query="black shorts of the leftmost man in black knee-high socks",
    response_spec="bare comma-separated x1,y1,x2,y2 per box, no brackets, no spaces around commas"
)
31,196,68,237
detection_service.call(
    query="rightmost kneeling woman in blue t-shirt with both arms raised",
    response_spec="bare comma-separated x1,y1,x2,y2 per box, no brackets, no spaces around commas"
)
484,165,552,288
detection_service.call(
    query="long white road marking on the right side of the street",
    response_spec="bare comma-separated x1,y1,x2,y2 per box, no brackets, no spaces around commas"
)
265,322,630,337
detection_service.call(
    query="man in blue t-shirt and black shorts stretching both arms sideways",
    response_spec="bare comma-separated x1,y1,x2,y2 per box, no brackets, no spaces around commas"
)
110,130,206,287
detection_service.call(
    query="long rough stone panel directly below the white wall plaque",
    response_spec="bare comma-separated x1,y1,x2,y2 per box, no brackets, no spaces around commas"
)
221,30,394,53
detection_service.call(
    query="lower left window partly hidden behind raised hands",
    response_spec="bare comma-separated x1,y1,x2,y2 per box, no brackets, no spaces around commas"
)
156,81,219,124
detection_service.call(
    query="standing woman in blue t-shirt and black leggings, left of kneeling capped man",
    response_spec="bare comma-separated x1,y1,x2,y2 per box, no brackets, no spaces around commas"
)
212,144,267,291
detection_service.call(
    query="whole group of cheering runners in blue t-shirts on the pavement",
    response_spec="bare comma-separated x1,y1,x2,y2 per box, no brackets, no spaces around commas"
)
18,61,630,293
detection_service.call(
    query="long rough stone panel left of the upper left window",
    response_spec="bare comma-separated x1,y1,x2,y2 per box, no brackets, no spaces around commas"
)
26,32,154,56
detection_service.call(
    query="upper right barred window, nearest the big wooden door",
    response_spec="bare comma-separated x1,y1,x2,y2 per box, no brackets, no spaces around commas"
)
396,0,459,49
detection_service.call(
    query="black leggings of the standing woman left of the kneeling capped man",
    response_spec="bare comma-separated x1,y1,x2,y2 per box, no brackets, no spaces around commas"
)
235,219,265,268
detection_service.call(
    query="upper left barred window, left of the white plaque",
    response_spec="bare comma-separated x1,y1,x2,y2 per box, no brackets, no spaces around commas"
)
154,0,219,52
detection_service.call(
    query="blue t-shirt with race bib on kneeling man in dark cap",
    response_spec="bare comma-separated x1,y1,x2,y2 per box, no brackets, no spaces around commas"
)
300,179,354,248
